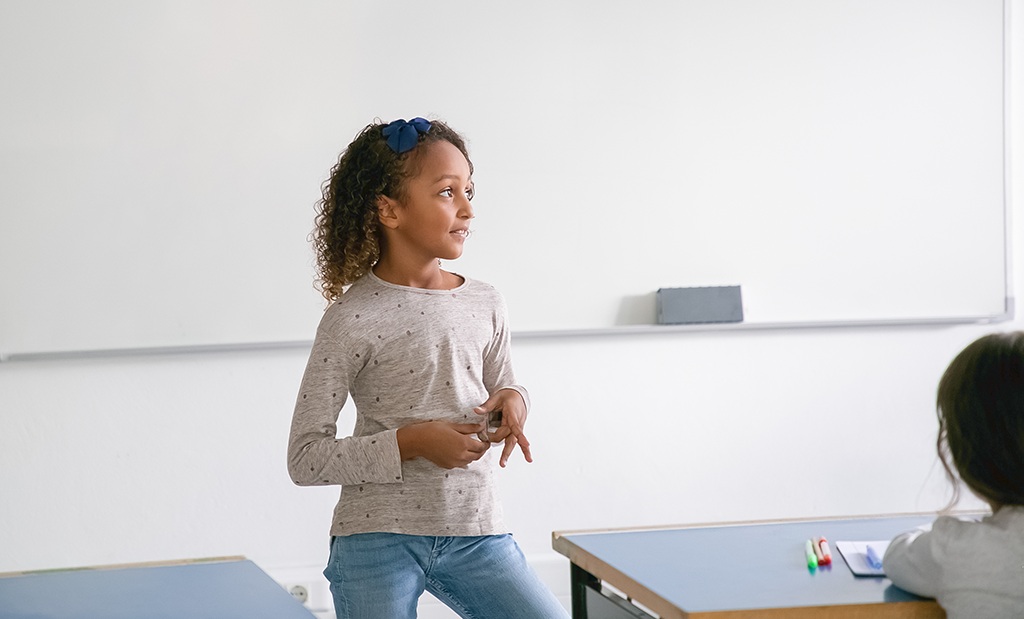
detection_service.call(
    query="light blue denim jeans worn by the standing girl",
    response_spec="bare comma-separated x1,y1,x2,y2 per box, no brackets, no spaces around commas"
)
324,533,568,619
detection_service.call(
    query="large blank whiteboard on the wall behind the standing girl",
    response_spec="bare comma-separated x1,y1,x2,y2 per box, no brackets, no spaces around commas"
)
0,0,1009,355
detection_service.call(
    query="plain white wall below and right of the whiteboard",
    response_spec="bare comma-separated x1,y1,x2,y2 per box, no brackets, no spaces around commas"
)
0,0,1024,616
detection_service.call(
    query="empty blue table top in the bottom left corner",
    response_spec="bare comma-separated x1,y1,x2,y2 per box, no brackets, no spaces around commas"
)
0,559,313,619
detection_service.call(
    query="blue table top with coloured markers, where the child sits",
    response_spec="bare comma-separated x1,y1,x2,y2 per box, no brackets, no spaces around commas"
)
554,515,946,613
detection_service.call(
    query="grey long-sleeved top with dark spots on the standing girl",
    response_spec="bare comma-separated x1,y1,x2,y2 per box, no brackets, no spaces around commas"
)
288,274,529,535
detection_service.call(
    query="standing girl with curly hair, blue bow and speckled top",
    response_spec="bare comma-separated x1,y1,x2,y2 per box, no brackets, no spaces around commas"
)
288,118,567,619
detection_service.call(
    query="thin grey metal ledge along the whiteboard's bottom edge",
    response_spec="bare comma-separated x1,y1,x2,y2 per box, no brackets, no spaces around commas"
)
0,305,1014,363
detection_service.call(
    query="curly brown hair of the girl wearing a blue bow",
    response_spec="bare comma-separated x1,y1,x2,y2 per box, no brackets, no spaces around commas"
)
310,119,473,302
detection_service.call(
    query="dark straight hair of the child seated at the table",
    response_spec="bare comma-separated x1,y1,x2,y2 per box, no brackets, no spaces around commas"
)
937,331,1024,508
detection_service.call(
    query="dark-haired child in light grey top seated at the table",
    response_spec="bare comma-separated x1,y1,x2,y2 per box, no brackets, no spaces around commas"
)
883,332,1024,619
